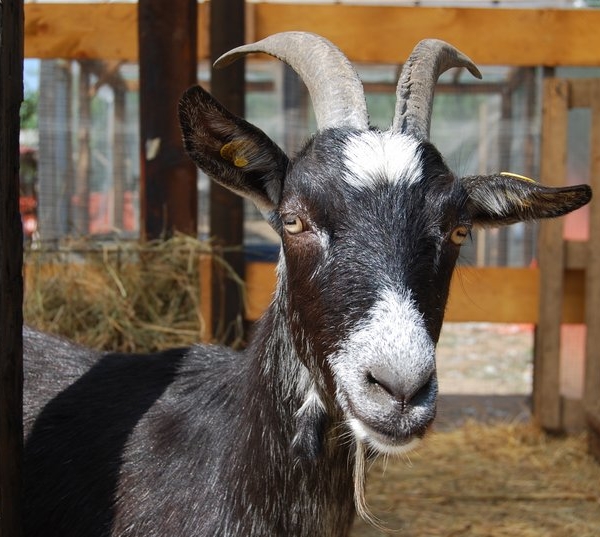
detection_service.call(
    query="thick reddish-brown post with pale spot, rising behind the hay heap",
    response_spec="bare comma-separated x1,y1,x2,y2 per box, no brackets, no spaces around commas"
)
138,0,198,239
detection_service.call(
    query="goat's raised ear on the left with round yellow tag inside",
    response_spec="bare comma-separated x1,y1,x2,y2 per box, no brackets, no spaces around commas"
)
179,86,288,214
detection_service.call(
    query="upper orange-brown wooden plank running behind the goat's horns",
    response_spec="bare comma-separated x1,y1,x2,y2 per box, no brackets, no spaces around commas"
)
255,4,600,66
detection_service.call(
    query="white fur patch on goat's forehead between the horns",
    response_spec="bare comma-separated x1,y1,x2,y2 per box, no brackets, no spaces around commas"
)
344,131,423,188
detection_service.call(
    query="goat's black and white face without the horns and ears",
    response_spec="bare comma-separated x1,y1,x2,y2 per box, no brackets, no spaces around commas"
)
278,130,470,451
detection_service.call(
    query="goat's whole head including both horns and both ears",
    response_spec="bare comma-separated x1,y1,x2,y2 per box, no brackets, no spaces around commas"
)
180,33,591,453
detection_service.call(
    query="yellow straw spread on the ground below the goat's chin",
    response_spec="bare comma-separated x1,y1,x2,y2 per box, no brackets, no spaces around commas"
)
352,423,600,537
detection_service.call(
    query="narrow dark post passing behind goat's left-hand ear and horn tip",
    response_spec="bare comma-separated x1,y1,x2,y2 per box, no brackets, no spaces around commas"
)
210,0,245,344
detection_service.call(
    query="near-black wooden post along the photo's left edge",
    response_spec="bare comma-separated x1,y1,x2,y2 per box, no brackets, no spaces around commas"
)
0,0,23,537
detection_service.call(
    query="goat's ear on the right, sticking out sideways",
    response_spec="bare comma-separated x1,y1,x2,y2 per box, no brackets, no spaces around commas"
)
461,173,592,226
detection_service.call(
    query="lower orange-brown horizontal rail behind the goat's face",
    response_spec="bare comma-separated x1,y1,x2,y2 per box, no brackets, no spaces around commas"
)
246,262,585,324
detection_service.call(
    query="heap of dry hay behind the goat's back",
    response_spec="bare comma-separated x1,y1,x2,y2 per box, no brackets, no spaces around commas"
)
24,235,241,352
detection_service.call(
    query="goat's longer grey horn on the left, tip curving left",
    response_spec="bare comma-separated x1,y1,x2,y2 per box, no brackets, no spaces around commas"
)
215,32,369,130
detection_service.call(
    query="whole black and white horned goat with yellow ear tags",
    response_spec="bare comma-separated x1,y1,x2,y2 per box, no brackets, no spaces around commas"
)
24,32,591,537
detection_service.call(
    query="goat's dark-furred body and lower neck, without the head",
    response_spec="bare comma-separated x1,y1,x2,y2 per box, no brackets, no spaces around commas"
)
24,318,353,537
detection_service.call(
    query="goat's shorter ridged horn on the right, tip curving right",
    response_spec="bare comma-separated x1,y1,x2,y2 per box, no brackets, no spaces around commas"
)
392,39,481,140
